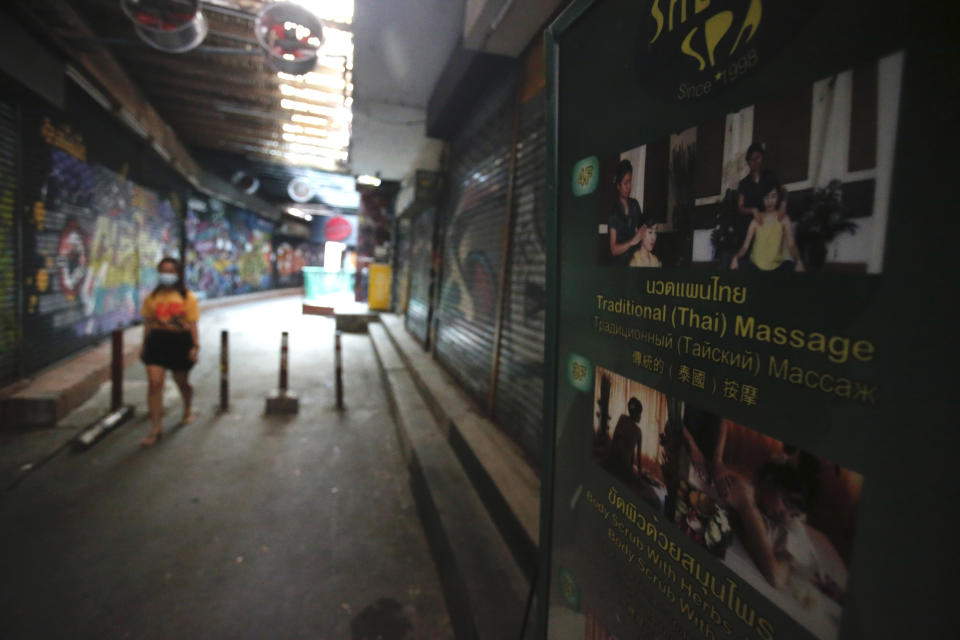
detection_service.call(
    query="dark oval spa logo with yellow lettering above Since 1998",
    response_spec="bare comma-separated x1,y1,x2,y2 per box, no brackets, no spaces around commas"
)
638,0,822,101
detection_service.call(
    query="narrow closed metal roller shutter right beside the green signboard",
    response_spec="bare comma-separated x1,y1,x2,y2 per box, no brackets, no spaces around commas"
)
494,92,546,459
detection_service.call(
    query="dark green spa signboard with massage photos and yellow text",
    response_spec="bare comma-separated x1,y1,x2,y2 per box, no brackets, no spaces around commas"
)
538,0,960,640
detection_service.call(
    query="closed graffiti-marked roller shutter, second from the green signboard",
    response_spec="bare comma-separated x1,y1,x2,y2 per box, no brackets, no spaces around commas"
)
435,93,514,403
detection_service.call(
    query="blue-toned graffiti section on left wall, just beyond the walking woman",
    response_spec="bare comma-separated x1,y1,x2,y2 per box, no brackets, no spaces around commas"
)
186,198,273,298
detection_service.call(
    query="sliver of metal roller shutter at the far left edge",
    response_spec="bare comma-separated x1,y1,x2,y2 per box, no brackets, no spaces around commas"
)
0,102,20,387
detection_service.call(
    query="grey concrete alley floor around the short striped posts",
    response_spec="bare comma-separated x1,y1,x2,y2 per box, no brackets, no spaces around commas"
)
0,297,453,640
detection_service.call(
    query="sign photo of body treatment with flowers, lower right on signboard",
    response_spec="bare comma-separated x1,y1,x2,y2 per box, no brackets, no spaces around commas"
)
664,403,863,638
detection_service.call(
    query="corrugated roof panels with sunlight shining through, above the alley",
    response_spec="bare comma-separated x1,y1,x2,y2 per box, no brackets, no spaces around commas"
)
20,0,353,195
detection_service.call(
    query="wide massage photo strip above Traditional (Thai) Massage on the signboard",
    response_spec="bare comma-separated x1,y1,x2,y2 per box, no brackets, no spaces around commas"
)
595,51,904,274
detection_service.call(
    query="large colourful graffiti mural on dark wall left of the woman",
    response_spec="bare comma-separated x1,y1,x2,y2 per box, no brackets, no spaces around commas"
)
24,118,179,368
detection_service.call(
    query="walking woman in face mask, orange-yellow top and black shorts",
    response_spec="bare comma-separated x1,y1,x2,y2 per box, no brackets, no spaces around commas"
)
140,258,200,446
